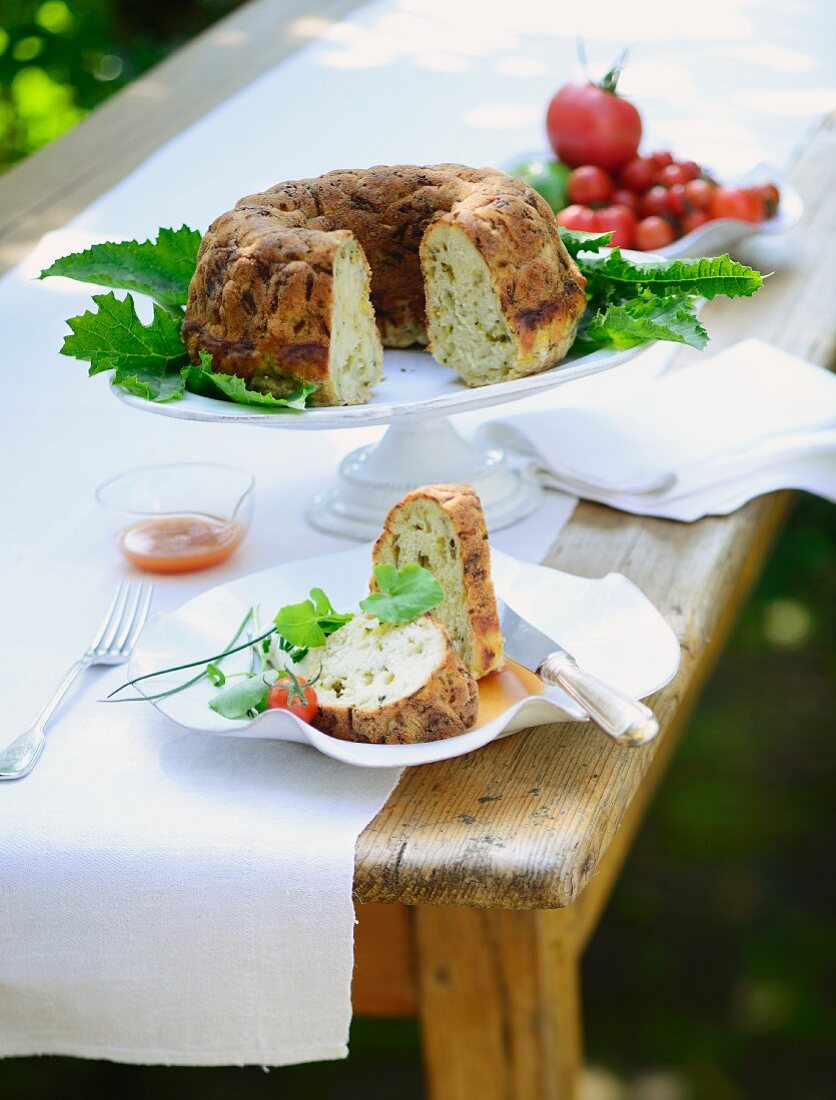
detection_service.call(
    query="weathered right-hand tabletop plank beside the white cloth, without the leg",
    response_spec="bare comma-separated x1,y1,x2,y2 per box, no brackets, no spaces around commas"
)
355,119,836,909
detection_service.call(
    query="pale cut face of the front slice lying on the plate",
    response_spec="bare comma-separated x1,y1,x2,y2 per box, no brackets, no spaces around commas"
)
297,614,447,711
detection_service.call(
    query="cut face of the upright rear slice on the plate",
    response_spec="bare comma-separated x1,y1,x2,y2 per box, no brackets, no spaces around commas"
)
377,501,473,669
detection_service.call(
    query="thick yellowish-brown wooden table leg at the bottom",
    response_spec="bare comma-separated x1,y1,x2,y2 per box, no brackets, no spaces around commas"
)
414,906,581,1100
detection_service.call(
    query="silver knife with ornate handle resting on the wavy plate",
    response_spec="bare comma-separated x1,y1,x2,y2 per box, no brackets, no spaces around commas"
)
497,600,659,747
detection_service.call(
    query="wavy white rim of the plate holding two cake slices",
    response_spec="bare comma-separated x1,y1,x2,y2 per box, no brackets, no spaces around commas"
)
130,545,680,768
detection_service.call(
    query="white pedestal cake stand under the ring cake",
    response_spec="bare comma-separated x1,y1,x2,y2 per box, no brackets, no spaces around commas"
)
113,344,648,540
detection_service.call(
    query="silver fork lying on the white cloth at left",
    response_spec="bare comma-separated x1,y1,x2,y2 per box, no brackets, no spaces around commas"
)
0,582,154,779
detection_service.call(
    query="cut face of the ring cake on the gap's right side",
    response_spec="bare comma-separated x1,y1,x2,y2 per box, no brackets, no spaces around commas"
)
422,223,516,386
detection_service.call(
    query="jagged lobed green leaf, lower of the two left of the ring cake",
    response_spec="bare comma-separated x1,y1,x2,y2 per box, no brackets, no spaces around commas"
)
61,292,188,402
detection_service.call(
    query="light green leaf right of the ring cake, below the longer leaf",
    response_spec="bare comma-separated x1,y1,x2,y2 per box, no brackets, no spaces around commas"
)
572,292,708,355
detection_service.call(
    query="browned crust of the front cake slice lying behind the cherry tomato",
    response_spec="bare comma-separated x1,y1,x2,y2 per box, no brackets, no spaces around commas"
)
316,627,479,745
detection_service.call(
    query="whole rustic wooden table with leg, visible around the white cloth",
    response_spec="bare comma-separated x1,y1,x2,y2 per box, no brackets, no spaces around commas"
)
0,0,836,1100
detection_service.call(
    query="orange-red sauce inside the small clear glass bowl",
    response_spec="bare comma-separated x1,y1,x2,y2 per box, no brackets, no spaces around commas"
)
117,516,244,573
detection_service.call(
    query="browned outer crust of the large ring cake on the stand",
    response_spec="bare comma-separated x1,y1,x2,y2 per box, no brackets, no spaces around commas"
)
183,164,586,404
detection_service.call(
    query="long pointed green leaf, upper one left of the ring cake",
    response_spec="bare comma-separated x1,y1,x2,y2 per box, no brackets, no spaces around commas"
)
40,226,200,309
